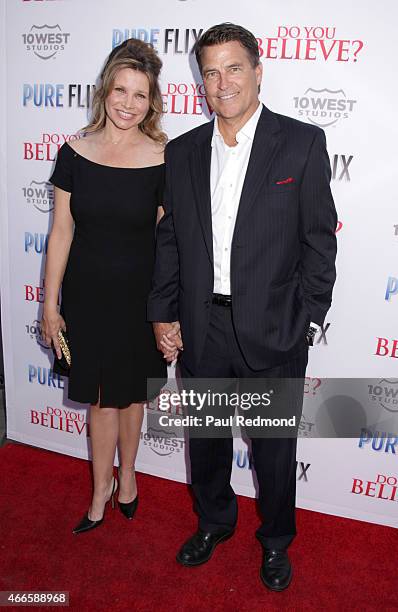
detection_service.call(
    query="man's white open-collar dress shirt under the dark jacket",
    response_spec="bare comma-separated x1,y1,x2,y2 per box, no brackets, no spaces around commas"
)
210,103,262,295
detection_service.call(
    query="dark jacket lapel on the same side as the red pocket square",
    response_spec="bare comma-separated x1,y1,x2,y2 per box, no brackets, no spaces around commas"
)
234,106,282,237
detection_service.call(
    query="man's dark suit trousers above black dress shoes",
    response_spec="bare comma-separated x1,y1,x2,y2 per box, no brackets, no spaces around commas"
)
180,305,308,549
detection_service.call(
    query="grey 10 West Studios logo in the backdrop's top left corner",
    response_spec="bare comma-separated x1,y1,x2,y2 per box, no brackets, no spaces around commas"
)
22,23,70,60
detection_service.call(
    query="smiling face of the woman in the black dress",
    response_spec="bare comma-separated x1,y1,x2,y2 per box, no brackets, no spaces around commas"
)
105,68,149,130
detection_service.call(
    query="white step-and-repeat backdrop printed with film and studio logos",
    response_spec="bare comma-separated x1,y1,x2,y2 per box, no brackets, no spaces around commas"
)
0,0,398,527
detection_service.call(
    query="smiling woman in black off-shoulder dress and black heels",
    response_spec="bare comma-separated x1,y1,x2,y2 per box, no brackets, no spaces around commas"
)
43,39,166,533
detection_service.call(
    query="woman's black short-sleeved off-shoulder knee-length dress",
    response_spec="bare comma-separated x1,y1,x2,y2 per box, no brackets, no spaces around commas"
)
50,144,167,408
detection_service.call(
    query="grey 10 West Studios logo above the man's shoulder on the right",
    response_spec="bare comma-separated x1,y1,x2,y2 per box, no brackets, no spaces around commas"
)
293,87,357,128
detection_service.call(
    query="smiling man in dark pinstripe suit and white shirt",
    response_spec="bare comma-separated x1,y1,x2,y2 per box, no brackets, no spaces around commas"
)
148,23,337,591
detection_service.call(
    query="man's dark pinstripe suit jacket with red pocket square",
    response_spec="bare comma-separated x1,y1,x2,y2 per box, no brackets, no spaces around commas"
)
148,107,337,371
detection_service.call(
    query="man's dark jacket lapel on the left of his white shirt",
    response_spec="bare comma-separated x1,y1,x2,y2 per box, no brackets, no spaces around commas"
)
189,121,214,263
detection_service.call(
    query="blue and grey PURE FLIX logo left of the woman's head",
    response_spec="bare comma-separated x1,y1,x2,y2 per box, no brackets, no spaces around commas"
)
22,83,95,108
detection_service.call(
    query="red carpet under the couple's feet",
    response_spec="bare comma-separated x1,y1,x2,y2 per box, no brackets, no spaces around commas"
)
0,444,398,612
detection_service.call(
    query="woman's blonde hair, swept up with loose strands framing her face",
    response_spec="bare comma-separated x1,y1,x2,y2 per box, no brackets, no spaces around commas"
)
83,38,167,144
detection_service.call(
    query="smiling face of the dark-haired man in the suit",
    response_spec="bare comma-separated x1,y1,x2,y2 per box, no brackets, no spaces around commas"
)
202,40,263,125
